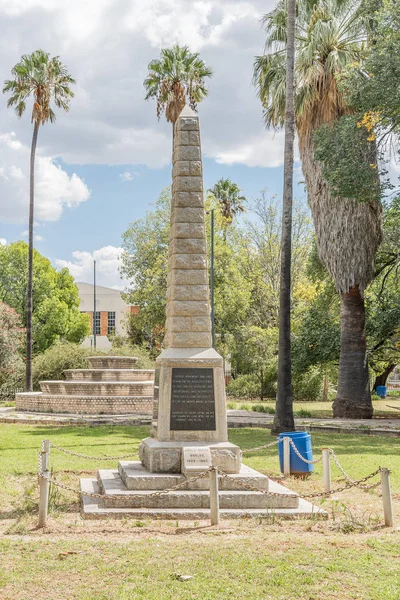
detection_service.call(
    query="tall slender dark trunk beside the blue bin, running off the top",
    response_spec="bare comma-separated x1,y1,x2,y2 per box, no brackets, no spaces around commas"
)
272,0,296,434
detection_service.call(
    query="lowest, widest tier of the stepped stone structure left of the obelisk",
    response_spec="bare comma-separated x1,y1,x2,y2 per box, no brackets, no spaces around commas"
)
15,392,153,415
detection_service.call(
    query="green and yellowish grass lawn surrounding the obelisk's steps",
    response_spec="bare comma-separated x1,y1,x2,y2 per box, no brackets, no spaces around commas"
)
0,424,400,600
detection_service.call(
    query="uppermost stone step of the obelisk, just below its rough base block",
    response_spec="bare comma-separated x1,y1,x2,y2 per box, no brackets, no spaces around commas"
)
118,460,269,491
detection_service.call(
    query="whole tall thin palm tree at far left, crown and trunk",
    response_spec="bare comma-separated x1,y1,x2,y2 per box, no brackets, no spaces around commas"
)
3,50,75,392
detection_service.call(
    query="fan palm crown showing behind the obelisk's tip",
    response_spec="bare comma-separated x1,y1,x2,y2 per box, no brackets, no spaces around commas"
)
144,44,212,124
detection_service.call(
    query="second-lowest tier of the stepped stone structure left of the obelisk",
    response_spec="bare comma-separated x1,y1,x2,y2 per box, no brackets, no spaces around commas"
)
40,380,153,396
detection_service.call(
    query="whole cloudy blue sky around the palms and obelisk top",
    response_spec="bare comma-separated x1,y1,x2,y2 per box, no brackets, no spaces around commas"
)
0,0,301,288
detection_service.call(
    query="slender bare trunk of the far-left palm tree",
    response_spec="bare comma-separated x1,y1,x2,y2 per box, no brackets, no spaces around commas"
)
25,122,39,392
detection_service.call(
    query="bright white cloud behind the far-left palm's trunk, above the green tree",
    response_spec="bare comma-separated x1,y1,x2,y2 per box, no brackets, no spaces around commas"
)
0,133,90,223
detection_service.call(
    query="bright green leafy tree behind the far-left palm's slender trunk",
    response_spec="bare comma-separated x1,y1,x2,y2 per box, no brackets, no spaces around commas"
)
0,242,90,354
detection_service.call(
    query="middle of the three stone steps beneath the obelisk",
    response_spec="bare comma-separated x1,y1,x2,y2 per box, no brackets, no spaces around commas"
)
98,470,299,509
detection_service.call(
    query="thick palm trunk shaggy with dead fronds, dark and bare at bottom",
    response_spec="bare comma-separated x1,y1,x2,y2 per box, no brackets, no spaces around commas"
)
299,132,382,419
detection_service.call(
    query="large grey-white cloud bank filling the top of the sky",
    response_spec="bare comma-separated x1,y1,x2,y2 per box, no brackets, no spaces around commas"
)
0,0,277,173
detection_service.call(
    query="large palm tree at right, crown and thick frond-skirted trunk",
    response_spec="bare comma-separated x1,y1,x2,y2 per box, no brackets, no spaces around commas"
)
254,0,382,418
